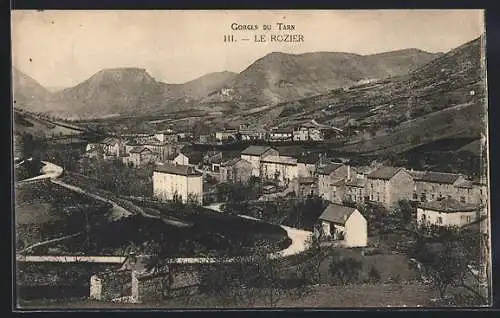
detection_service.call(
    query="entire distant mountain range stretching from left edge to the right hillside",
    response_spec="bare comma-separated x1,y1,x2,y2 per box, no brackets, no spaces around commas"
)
14,49,437,119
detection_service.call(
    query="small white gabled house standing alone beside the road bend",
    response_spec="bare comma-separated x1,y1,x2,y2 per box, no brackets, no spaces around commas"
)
319,203,368,247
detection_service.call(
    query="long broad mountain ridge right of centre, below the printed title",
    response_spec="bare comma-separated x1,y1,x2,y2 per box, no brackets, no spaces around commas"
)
204,49,440,108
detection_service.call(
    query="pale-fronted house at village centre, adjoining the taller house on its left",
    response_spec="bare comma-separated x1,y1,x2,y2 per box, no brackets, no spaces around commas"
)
260,156,299,186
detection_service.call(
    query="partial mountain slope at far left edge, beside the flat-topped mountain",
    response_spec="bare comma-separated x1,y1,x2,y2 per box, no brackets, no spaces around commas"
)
12,67,51,111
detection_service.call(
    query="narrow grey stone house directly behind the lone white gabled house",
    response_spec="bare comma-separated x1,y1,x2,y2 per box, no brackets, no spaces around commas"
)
316,163,351,202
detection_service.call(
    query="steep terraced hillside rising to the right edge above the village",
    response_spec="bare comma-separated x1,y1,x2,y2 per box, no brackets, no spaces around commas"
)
250,38,486,159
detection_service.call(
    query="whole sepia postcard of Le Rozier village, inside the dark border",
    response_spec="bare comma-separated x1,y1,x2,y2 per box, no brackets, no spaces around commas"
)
11,9,492,311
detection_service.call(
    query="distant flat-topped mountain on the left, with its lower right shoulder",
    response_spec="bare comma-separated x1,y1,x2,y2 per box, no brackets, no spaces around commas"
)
37,68,234,118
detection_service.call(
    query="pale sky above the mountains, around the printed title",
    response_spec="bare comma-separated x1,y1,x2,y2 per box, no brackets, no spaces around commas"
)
11,10,484,88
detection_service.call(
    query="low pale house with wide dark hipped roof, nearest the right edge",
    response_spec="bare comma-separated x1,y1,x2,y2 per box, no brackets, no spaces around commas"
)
417,197,481,227
